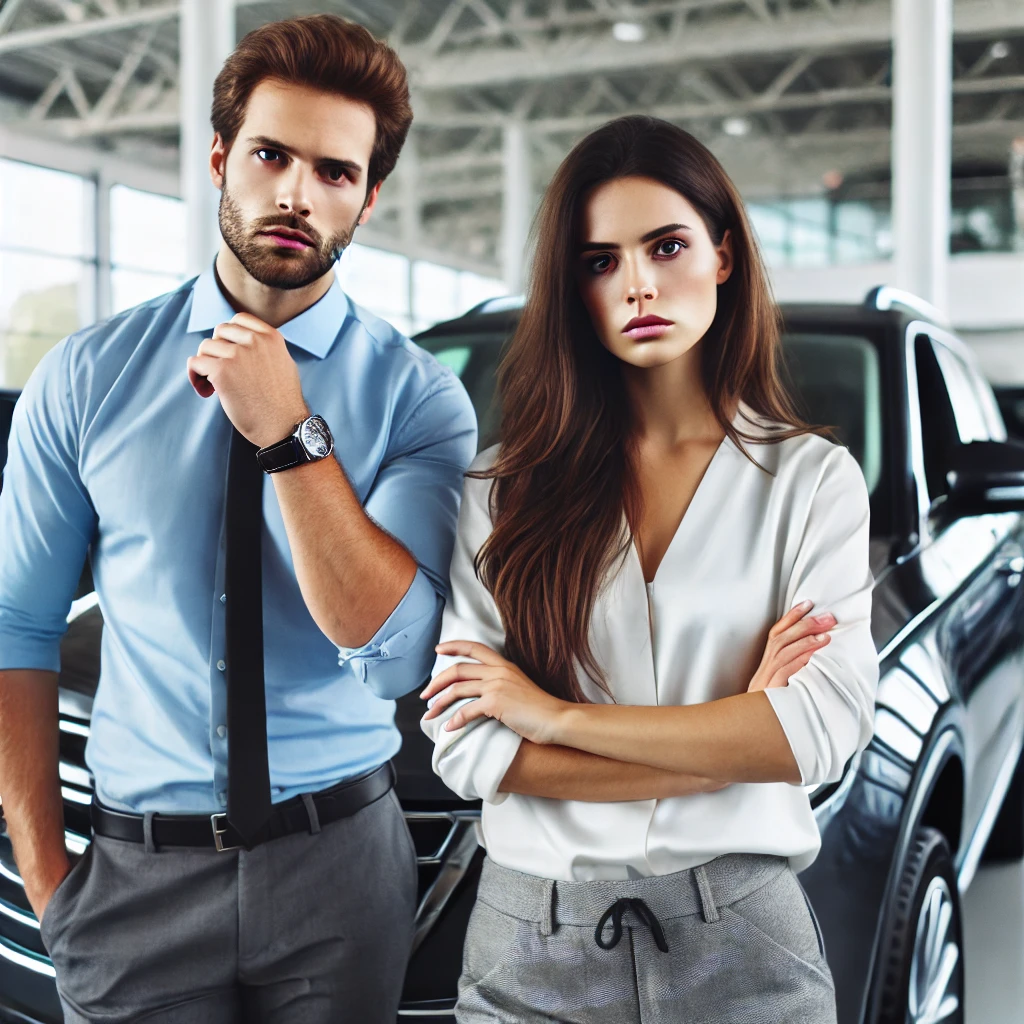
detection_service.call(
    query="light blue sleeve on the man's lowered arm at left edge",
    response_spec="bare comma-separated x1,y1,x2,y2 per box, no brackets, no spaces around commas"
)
0,341,96,672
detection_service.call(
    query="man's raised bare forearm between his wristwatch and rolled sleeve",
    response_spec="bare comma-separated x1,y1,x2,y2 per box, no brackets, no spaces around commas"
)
271,458,417,647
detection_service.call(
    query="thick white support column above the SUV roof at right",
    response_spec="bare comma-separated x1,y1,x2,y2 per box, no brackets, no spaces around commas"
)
892,0,952,309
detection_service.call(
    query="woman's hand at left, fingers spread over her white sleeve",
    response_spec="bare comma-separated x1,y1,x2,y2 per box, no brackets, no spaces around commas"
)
420,640,568,743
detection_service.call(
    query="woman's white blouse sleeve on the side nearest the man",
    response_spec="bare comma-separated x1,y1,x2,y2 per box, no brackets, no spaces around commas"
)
421,452,522,804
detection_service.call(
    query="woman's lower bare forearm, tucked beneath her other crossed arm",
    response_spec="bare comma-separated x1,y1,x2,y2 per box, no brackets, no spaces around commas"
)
498,739,722,803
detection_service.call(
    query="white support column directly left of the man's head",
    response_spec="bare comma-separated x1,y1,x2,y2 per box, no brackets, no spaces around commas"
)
179,0,236,275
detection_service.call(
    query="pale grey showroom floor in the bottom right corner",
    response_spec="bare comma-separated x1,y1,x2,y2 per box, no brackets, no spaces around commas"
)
964,861,1024,1024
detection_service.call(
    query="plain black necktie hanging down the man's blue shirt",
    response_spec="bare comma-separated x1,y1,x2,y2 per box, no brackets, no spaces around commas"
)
224,429,270,846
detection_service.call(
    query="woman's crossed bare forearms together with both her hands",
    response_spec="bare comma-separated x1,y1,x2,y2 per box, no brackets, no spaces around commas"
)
421,602,836,801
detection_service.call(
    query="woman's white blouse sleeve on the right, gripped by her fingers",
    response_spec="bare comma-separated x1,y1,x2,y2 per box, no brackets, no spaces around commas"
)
765,446,879,785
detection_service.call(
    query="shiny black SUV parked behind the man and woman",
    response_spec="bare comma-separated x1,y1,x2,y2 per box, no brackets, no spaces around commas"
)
0,288,1024,1024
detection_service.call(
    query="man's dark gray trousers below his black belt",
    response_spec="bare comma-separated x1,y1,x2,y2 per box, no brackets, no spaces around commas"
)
41,791,417,1024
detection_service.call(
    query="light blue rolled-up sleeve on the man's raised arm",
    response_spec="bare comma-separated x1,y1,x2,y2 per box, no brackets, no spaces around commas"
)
338,370,476,700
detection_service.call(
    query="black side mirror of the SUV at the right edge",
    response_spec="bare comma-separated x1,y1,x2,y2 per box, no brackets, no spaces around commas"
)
935,440,1024,518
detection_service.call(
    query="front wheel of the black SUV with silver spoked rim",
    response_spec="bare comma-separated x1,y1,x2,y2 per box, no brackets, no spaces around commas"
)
876,825,964,1024
